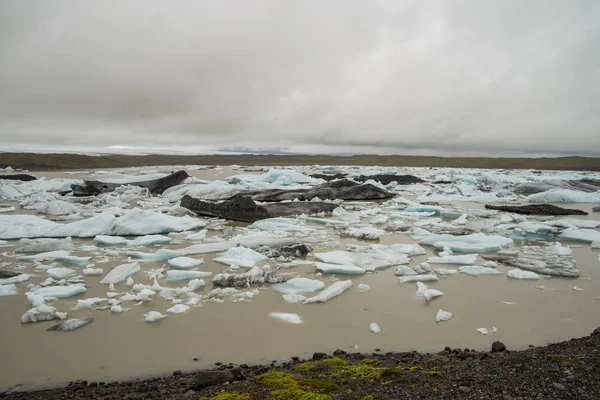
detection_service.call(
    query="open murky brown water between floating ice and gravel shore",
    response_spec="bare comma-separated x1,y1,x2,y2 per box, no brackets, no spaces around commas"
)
0,166,600,389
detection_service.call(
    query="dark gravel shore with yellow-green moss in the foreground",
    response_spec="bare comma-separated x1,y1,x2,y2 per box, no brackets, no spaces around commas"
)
0,328,600,400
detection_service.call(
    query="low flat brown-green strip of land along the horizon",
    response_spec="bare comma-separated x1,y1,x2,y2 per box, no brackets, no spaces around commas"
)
0,153,600,171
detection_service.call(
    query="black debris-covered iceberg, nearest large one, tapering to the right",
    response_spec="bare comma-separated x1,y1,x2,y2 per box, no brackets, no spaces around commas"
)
181,195,337,222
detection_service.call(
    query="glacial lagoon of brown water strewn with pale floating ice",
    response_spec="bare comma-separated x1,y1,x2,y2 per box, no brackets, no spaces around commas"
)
0,166,600,390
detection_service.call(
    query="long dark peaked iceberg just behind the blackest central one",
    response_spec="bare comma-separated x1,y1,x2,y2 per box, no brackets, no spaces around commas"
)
246,179,394,202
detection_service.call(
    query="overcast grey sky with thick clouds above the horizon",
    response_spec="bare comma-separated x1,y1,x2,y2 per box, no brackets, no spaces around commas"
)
0,0,600,155
